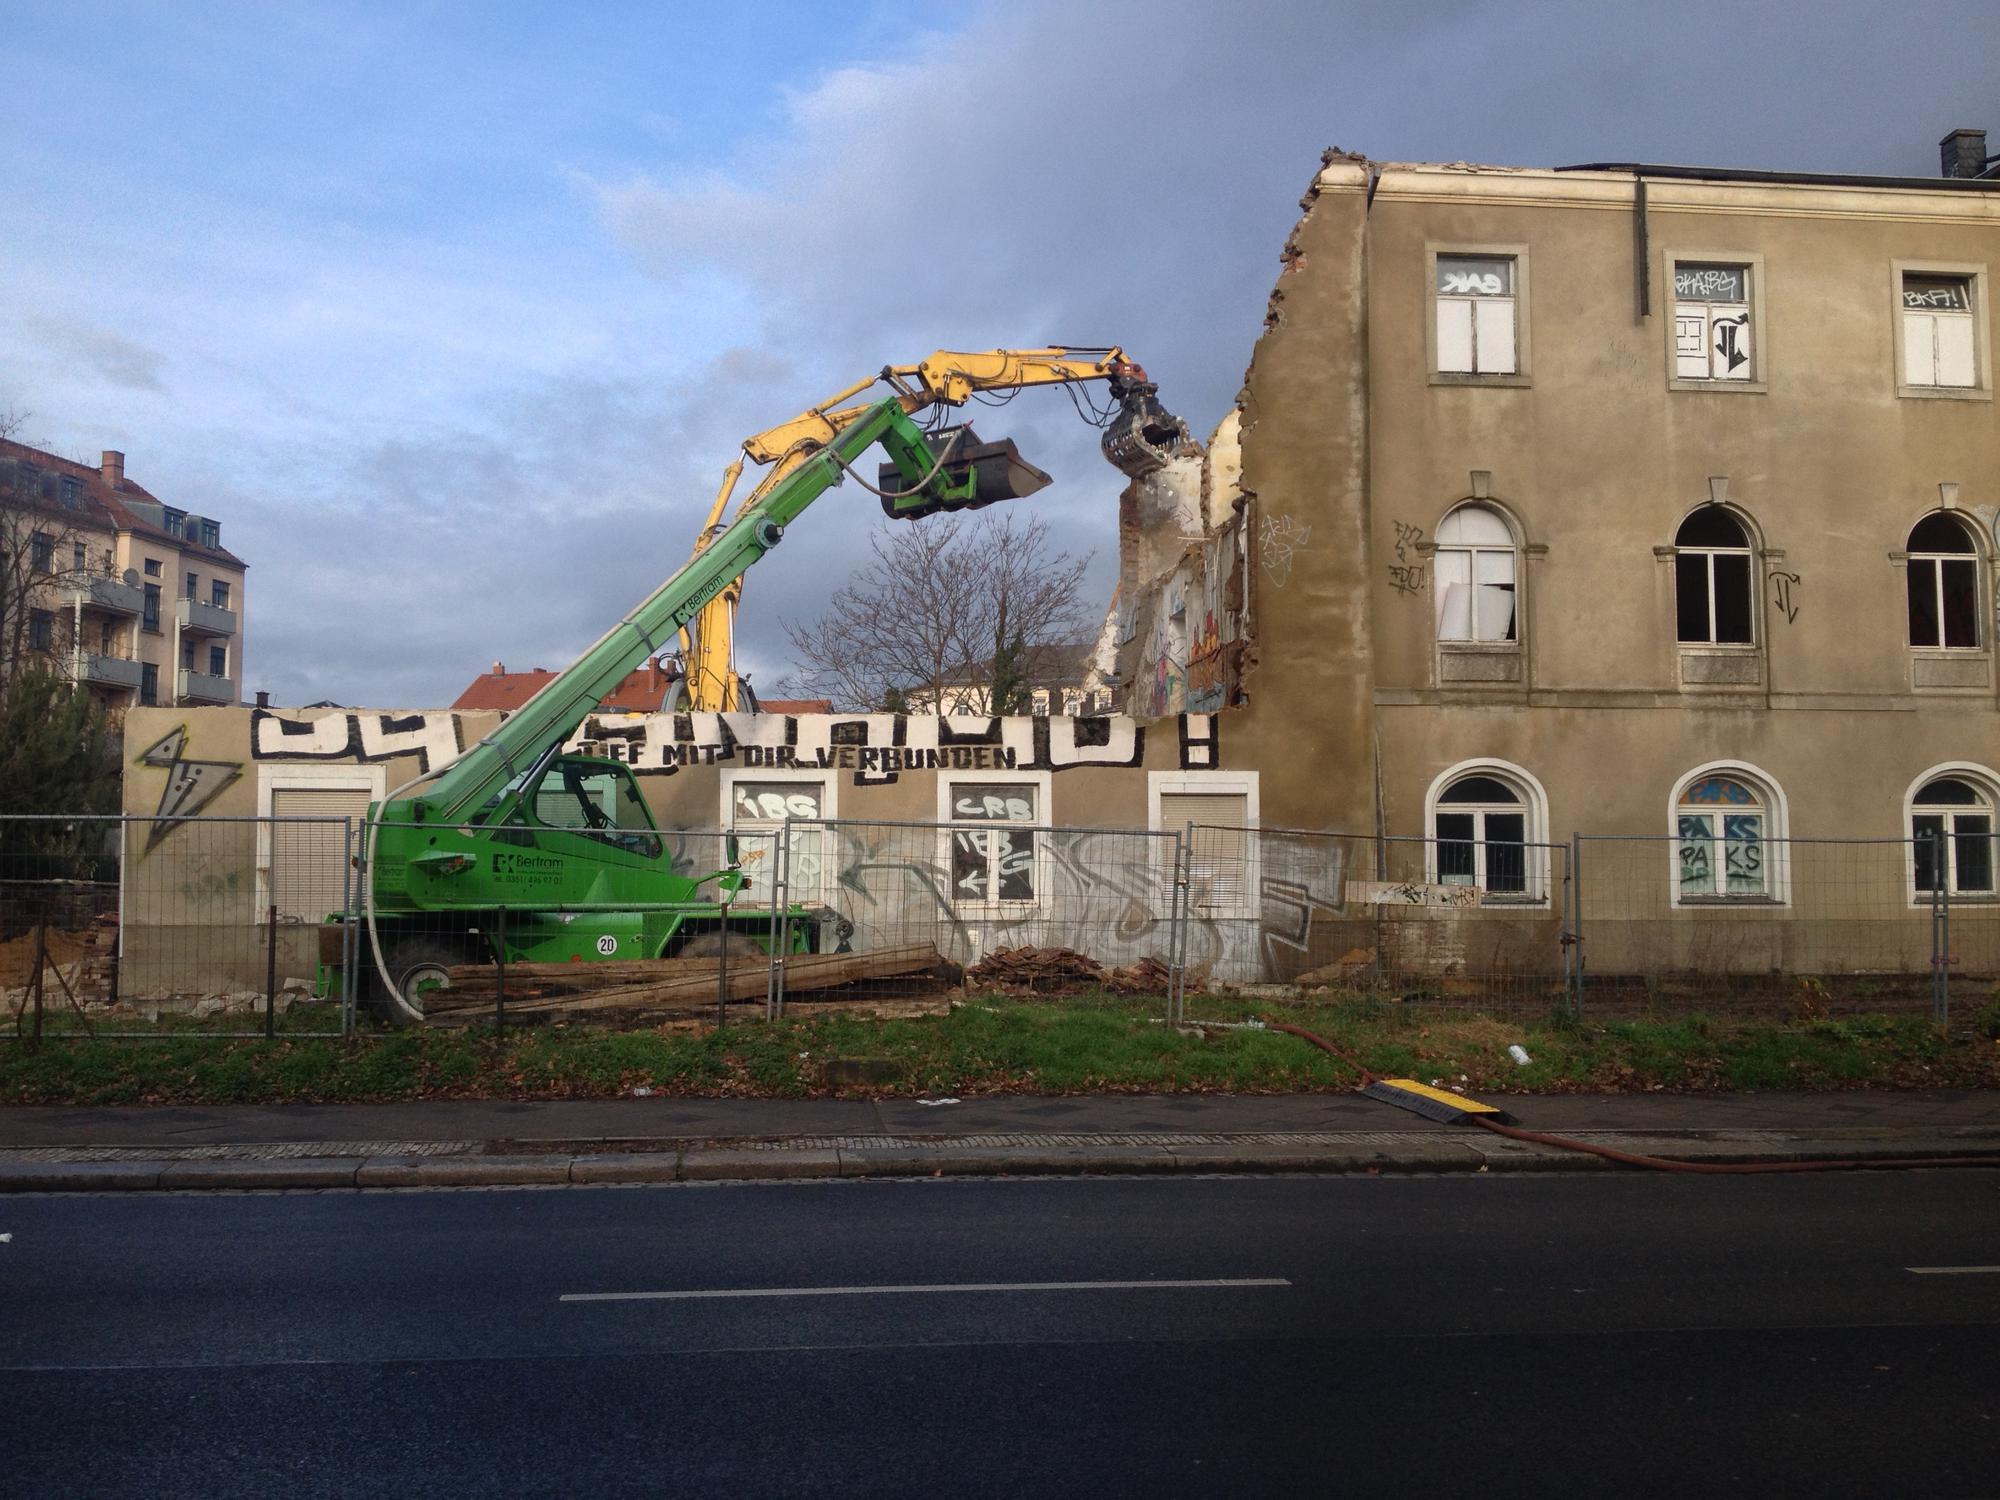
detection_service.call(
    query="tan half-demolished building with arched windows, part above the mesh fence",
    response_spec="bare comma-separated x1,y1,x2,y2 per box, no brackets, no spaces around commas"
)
1224,132,2000,904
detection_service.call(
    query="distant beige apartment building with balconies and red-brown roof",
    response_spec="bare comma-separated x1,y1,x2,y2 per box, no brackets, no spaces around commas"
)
0,442,244,710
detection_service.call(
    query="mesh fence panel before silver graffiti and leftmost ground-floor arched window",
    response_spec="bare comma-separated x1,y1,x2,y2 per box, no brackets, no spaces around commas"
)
1186,824,1570,1014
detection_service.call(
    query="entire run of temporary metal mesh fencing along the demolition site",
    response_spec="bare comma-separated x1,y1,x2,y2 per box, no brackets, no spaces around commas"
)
11,816,2000,1036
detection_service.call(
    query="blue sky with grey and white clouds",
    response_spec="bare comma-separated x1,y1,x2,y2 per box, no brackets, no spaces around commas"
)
0,0,2000,708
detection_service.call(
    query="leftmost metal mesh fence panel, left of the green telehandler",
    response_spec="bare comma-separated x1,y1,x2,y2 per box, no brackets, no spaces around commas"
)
0,816,352,1038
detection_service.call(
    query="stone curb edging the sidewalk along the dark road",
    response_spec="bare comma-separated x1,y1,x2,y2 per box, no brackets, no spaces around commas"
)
0,1130,2000,1194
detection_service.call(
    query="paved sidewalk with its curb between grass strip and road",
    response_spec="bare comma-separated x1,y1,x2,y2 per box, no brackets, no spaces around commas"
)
0,1090,2000,1192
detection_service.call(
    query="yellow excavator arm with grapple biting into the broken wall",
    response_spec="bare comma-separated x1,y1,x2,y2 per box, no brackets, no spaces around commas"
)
680,346,1188,712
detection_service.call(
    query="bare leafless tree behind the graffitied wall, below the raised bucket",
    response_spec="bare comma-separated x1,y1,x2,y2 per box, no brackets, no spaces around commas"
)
784,512,1090,712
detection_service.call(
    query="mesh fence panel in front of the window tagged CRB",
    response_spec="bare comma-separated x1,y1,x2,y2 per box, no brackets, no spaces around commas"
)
760,824,1182,1008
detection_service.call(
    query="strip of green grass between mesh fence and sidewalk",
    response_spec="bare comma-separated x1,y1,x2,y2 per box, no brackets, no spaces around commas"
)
0,996,2000,1104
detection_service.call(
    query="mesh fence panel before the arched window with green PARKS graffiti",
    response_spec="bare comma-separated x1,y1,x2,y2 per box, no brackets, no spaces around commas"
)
1578,830,1944,1016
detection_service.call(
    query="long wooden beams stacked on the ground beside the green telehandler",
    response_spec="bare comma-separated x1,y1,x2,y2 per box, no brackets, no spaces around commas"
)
424,942,944,1026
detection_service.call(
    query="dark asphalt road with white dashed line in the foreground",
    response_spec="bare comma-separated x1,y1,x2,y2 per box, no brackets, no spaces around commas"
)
0,1172,2000,1500
